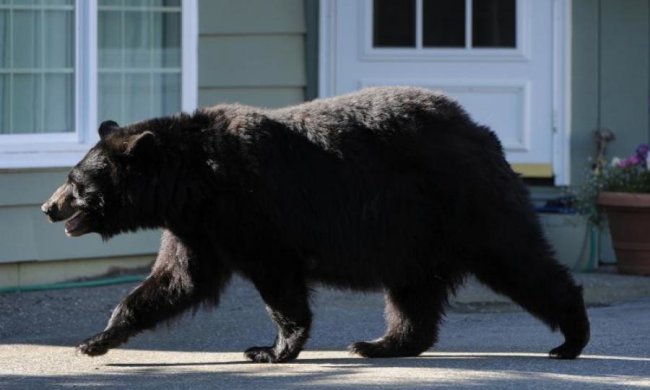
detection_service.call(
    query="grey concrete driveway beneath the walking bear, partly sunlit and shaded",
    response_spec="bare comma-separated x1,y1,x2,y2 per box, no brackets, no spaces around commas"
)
0,279,650,389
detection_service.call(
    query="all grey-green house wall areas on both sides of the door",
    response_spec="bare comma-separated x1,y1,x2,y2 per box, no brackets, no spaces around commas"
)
0,0,650,286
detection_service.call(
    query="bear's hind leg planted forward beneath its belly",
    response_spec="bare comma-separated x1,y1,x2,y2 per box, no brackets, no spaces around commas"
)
350,282,448,357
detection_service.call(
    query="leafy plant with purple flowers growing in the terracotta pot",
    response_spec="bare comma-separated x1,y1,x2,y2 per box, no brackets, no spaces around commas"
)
574,144,650,226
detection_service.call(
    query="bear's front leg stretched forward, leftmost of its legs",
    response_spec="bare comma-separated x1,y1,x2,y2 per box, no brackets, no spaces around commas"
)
77,231,230,356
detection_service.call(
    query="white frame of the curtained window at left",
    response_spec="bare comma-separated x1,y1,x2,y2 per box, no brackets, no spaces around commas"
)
0,0,199,169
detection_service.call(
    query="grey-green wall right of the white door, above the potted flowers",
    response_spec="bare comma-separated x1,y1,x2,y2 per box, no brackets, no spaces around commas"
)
571,0,650,184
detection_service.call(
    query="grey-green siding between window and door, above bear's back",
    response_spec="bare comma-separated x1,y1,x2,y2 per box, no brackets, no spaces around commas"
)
199,0,307,107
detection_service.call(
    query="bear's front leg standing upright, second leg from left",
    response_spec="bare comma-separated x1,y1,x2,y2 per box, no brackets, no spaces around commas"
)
244,271,312,363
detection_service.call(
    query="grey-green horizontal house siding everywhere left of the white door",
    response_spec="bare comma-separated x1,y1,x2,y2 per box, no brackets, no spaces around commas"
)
0,0,309,287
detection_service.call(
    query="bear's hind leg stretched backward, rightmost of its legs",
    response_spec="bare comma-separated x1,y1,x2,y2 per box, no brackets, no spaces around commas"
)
476,245,589,359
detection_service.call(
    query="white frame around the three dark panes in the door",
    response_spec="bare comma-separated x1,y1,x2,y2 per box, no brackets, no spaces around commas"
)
359,0,530,61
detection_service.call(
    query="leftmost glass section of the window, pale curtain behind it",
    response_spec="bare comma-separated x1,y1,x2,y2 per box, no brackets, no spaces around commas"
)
0,0,75,134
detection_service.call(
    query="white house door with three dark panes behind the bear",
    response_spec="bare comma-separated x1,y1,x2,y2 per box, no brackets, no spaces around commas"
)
320,0,569,184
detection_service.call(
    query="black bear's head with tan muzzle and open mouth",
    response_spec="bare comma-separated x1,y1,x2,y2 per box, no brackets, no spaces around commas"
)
41,121,156,238
